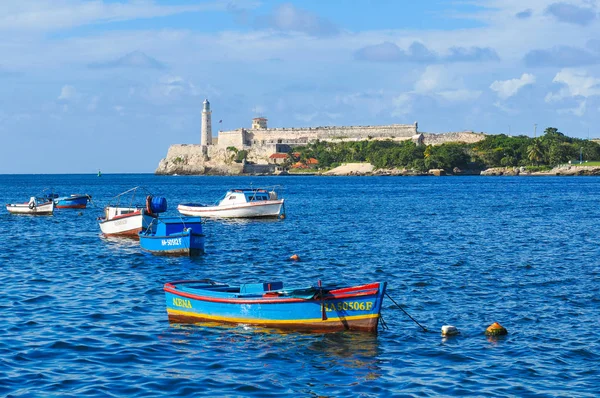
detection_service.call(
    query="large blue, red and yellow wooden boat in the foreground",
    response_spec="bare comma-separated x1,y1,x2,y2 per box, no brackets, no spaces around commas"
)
164,279,387,333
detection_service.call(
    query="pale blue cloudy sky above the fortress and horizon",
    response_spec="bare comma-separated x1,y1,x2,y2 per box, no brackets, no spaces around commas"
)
0,0,600,174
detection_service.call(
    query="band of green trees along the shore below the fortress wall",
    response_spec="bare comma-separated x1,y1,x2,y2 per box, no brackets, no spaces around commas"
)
294,127,600,171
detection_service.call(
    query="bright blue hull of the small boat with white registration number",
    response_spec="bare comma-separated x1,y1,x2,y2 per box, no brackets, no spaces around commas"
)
139,231,204,256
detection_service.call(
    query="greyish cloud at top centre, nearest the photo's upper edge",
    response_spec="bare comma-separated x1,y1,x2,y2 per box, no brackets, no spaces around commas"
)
255,3,340,37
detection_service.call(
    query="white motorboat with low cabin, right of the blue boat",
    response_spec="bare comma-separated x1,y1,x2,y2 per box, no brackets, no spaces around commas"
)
177,188,285,218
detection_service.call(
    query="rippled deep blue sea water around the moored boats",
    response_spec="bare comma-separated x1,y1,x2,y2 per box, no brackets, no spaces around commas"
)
0,174,600,397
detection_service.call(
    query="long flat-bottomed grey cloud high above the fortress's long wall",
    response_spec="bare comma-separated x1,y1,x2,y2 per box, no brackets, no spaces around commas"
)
354,41,500,63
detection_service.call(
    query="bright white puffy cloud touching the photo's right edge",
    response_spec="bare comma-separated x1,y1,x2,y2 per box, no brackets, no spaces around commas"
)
545,69,600,102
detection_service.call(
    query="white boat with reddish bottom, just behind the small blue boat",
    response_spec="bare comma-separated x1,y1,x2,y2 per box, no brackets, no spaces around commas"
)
98,187,160,238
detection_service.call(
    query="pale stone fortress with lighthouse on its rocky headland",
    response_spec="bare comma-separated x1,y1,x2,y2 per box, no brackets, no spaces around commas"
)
156,100,484,174
